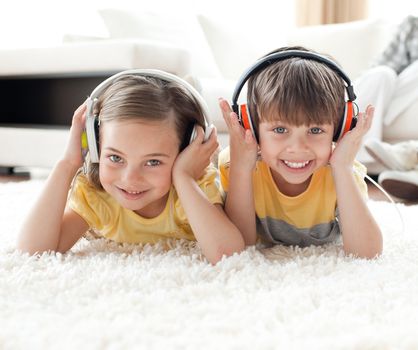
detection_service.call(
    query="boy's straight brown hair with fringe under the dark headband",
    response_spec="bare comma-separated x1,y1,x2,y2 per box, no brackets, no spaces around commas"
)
247,47,345,130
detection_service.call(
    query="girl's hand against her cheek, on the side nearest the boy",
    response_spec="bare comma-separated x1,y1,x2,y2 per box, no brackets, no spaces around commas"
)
172,126,219,184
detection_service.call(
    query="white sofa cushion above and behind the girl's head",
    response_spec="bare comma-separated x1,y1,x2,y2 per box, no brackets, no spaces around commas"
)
99,9,220,78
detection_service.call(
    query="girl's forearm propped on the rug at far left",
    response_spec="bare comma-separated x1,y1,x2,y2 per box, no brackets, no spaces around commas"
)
17,161,78,254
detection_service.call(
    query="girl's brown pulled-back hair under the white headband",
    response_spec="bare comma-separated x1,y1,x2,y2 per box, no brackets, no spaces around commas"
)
86,75,205,190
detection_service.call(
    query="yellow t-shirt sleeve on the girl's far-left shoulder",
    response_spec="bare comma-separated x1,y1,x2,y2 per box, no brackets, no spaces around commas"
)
69,174,109,230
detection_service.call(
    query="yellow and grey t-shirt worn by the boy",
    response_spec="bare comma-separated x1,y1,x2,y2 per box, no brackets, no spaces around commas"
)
219,148,367,247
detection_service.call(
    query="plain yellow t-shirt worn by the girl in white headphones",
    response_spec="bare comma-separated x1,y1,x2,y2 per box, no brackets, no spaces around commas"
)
69,166,223,243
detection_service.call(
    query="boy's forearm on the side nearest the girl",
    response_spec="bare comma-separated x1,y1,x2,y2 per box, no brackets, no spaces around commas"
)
225,168,257,245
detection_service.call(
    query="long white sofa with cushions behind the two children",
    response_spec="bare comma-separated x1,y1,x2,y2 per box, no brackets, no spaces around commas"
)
0,9,418,174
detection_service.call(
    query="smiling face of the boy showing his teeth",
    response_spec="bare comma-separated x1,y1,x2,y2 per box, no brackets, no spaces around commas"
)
259,121,334,196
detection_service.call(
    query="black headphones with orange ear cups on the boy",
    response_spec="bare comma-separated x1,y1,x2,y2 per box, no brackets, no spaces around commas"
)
232,50,357,142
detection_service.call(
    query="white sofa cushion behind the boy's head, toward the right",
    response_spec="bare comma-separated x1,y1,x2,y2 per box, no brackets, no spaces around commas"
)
288,20,395,80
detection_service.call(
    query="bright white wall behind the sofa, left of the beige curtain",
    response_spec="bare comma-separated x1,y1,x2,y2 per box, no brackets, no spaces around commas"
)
0,0,294,48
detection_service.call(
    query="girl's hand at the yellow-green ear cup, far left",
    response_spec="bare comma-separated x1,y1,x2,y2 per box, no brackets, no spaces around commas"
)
63,102,86,169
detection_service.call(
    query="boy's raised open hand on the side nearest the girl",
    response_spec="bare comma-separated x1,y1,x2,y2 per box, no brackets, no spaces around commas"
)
219,98,258,171
